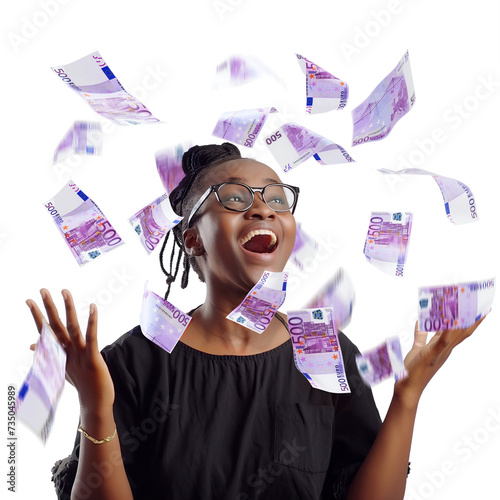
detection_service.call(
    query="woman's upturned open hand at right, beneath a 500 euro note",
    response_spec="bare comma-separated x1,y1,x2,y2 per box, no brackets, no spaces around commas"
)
395,316,486,407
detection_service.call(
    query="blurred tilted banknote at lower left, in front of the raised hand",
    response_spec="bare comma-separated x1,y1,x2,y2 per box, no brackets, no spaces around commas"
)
16,318,66,443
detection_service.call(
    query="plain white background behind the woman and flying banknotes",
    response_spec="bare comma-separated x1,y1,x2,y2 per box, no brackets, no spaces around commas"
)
0,0,500,499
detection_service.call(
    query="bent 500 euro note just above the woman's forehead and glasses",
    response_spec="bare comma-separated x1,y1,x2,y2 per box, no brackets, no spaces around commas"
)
265,123,354,172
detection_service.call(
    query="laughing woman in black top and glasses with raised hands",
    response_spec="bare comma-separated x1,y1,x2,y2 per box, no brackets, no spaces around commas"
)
27,143,481,500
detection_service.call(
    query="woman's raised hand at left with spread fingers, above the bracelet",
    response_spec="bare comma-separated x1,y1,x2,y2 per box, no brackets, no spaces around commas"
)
26,288,115,415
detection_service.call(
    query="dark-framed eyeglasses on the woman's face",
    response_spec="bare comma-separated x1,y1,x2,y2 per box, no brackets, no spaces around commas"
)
187,182,299,227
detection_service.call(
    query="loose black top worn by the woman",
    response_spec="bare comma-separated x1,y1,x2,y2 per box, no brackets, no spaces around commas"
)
53,315,381,500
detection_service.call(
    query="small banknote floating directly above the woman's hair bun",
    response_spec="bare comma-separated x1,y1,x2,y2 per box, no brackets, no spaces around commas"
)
212,108,276,148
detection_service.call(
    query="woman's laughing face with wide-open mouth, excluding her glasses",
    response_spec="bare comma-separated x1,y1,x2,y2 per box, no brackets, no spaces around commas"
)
185,159,295,292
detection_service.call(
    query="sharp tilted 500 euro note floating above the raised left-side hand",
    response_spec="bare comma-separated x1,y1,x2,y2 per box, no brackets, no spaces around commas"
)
44,180,122,265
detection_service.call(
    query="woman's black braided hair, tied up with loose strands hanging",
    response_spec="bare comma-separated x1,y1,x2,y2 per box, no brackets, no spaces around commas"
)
160,142,241,300
